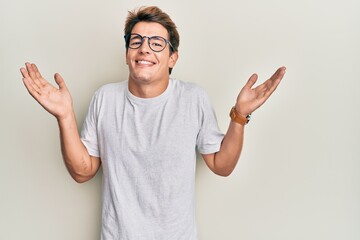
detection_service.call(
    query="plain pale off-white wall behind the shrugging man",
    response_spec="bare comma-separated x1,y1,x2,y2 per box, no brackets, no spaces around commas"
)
0,0,360,240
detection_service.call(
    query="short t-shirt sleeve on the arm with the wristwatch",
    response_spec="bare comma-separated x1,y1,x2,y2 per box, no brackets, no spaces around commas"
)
197,91,224,154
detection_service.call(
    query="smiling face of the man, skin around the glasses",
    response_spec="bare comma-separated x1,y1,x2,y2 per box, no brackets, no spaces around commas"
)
126,22,178,84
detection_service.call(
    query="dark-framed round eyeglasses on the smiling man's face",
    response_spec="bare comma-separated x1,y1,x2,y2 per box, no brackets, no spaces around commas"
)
124,33,174,52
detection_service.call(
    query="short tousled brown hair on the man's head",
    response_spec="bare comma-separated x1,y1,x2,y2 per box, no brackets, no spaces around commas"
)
124,6,180,73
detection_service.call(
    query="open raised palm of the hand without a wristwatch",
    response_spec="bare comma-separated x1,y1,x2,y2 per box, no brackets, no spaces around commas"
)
20,63,73,120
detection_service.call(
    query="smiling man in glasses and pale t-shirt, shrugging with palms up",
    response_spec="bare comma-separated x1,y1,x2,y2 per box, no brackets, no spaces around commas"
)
21,7,285,240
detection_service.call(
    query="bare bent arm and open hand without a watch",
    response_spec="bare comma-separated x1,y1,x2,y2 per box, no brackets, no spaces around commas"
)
20,63,101,183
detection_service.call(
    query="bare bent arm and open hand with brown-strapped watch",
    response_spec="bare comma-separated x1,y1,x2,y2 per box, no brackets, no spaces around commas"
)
202,67,286,176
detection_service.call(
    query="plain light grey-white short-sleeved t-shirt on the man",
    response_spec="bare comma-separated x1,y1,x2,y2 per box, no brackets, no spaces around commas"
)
81,79,224,240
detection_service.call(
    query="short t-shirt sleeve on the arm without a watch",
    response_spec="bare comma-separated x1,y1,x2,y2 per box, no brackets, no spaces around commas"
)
80,94,100,157
